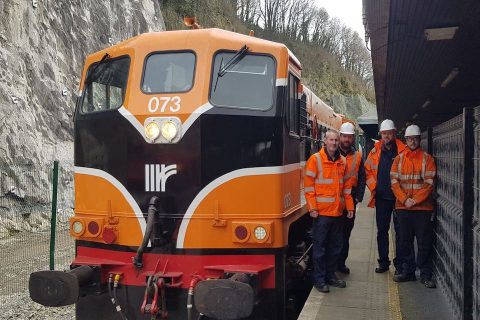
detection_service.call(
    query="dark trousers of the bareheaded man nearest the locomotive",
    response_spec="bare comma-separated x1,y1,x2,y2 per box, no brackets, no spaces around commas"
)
313,216,343,284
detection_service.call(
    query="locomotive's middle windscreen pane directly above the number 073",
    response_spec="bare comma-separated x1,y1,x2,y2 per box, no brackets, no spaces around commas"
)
142,52,195,93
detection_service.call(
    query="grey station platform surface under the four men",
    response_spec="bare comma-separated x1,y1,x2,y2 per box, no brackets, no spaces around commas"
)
298,204,453,320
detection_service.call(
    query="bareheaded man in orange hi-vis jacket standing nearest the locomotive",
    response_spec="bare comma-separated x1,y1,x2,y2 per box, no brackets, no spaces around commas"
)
304,130,355,293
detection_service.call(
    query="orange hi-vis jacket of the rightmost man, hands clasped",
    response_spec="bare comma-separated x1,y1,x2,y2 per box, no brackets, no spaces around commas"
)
390,148,437,211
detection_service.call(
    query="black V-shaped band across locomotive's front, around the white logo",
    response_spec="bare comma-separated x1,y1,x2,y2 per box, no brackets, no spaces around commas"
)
75,101,282,246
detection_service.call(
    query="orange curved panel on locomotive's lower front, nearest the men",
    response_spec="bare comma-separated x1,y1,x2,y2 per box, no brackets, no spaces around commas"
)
183,167,305,248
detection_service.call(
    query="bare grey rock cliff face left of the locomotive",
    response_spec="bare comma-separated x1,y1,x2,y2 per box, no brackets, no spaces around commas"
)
0,0,164,234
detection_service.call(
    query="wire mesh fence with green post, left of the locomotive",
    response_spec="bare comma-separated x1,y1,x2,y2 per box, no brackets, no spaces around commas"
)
0,161,74,304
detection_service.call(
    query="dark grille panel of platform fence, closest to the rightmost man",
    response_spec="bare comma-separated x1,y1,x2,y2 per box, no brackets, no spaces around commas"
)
432,115,464,315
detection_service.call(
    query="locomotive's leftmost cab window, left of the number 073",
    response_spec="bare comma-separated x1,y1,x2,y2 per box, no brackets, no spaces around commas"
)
81,57,130,113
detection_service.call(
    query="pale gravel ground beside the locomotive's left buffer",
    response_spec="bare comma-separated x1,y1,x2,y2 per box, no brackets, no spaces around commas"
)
0,230,75,320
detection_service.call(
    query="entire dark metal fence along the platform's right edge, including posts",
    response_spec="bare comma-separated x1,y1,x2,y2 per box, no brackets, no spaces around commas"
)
422,107,480,319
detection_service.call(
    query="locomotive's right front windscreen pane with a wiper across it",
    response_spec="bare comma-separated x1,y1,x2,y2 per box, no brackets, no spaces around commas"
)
210,52,275,110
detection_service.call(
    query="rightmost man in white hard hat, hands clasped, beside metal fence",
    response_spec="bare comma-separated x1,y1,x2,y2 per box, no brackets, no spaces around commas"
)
390,125,437,288
